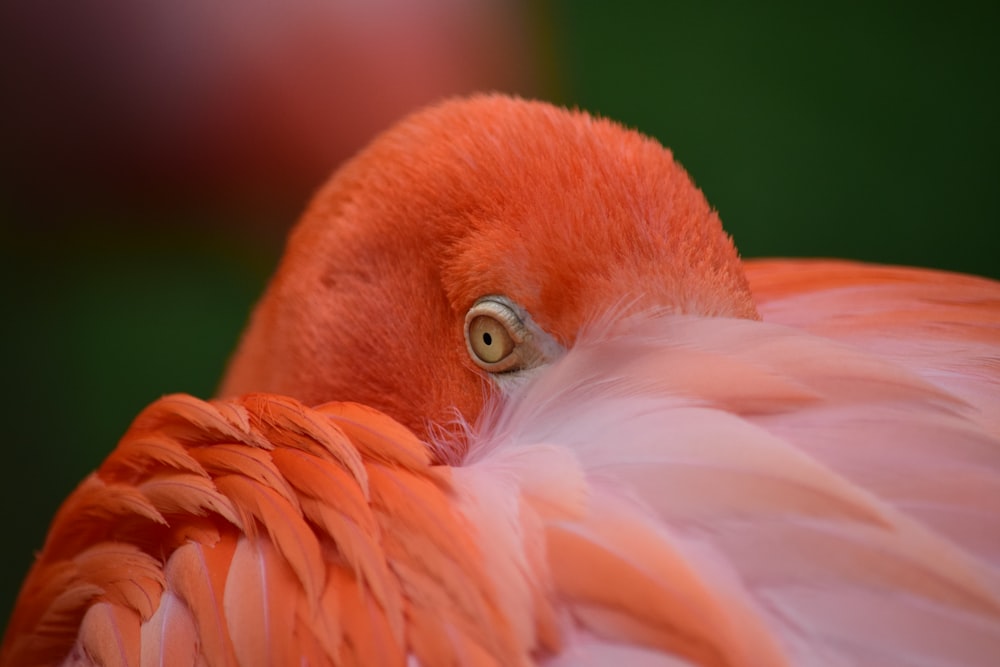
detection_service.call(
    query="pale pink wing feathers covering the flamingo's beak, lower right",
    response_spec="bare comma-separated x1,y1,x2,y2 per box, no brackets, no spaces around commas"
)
455,316,1000,666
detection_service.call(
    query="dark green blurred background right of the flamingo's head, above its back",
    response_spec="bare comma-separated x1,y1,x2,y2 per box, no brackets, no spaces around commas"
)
552,0,1000,277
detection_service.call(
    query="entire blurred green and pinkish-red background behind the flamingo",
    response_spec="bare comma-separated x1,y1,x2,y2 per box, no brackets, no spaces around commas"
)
0,0,1000,636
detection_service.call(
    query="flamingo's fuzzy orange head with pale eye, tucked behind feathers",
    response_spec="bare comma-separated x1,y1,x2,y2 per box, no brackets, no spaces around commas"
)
221,96,757,462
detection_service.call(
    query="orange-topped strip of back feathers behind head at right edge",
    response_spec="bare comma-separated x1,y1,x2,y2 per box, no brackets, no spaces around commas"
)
745,260,1000,433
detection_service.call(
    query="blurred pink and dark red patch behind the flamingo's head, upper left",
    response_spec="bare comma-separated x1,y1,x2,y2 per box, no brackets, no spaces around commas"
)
0,0,539,232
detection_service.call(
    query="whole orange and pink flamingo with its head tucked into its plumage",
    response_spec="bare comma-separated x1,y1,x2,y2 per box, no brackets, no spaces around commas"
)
0,94,1000,667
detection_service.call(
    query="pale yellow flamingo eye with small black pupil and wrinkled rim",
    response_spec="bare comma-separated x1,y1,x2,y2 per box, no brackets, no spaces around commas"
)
465,297,524,373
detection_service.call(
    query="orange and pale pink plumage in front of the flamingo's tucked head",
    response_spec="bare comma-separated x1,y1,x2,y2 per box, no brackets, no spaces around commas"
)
4,289,1000,666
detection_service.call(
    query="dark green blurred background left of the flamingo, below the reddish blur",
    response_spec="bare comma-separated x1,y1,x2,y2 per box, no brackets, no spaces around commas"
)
0,220,271,636
